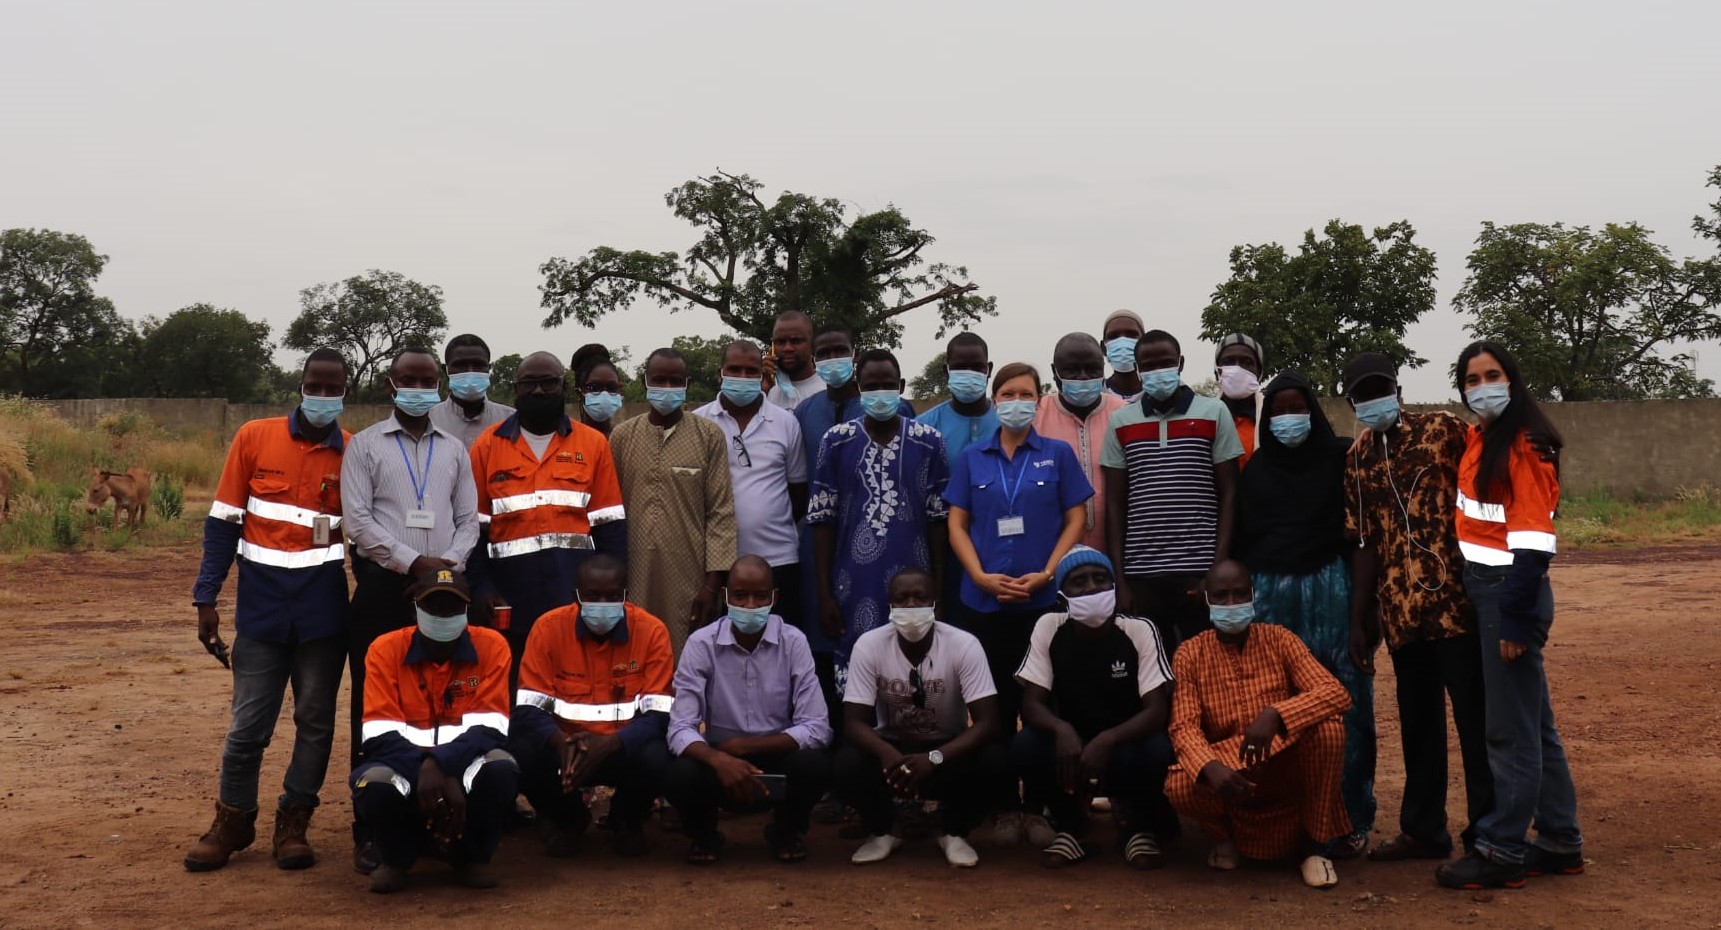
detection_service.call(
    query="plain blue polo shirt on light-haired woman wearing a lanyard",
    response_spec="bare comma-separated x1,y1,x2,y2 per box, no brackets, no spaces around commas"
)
945,429,1093,613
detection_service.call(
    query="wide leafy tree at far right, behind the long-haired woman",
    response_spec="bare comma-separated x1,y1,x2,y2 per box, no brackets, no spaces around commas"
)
1456,169,1721,401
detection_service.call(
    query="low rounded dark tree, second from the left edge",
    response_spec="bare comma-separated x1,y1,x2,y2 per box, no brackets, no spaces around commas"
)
138,303,274,403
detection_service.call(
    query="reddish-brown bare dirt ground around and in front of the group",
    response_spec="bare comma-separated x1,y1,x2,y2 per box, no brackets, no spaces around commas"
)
0,548,1721,928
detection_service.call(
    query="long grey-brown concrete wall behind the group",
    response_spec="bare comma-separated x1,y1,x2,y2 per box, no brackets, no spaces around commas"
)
26,398,1721,498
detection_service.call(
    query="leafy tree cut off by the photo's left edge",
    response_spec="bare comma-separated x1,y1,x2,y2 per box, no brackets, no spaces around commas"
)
0,229,127,396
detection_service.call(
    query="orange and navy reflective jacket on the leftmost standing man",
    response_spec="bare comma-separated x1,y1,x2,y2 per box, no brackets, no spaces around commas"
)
191,410,351,642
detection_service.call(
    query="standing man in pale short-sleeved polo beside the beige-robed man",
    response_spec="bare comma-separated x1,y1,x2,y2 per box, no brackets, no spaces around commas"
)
694,339,807,627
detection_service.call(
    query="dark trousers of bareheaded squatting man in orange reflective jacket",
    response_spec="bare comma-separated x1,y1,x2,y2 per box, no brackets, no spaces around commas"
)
508,737,669,830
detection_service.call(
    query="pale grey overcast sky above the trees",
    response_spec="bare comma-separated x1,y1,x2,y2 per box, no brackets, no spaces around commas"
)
0,0,1721,400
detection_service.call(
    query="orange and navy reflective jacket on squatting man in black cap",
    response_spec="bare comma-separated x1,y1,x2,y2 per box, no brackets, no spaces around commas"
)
353,627,513,794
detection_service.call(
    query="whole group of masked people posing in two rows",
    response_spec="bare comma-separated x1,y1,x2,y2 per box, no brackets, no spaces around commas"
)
184,310,1583,892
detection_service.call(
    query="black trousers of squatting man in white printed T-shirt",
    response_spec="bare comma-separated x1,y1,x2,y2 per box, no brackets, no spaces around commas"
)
835,741,1010,837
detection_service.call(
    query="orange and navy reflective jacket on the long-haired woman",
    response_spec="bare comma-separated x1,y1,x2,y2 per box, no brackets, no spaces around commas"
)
1458,427,1559,565
